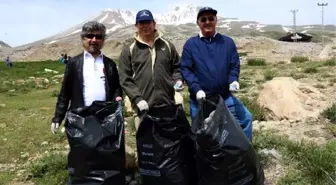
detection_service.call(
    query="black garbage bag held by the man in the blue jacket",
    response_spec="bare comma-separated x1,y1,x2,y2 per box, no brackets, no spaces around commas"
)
192,95,264,185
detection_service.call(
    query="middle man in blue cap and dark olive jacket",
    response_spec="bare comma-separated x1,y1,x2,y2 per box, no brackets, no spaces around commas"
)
119,10,183,129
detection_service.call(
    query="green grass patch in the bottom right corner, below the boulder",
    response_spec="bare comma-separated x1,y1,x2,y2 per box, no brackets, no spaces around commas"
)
253,131,336,185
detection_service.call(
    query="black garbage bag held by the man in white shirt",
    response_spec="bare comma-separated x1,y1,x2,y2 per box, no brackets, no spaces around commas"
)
65,101,126,185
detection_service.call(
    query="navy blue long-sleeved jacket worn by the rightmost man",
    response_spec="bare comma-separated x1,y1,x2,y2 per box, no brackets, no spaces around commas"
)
180,33,240,100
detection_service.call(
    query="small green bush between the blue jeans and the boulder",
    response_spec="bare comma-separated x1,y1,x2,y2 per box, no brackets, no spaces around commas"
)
240,97,265,121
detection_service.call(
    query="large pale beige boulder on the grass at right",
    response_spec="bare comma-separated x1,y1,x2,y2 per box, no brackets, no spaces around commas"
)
257,77,328,120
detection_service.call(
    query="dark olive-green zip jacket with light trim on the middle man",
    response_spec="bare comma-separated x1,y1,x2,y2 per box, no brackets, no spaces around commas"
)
119,32,182,110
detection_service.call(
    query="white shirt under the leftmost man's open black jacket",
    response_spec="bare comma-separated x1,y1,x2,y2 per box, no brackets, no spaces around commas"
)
83,51,106,106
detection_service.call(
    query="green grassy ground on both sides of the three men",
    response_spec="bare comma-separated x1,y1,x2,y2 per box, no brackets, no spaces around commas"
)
0,60,336,185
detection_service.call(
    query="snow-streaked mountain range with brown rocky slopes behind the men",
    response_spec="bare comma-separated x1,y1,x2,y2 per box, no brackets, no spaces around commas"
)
3,5,336,60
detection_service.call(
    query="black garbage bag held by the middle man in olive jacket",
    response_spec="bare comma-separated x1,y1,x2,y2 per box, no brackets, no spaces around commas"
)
136,105,197,185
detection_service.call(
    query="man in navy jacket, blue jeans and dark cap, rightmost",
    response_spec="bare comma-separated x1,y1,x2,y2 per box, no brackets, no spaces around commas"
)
181,7,252,140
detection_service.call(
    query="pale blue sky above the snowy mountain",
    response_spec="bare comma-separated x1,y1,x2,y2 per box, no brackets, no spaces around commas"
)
0,0,336,46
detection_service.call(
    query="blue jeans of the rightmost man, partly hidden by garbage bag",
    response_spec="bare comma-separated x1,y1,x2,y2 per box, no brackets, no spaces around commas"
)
189,95,252,141
